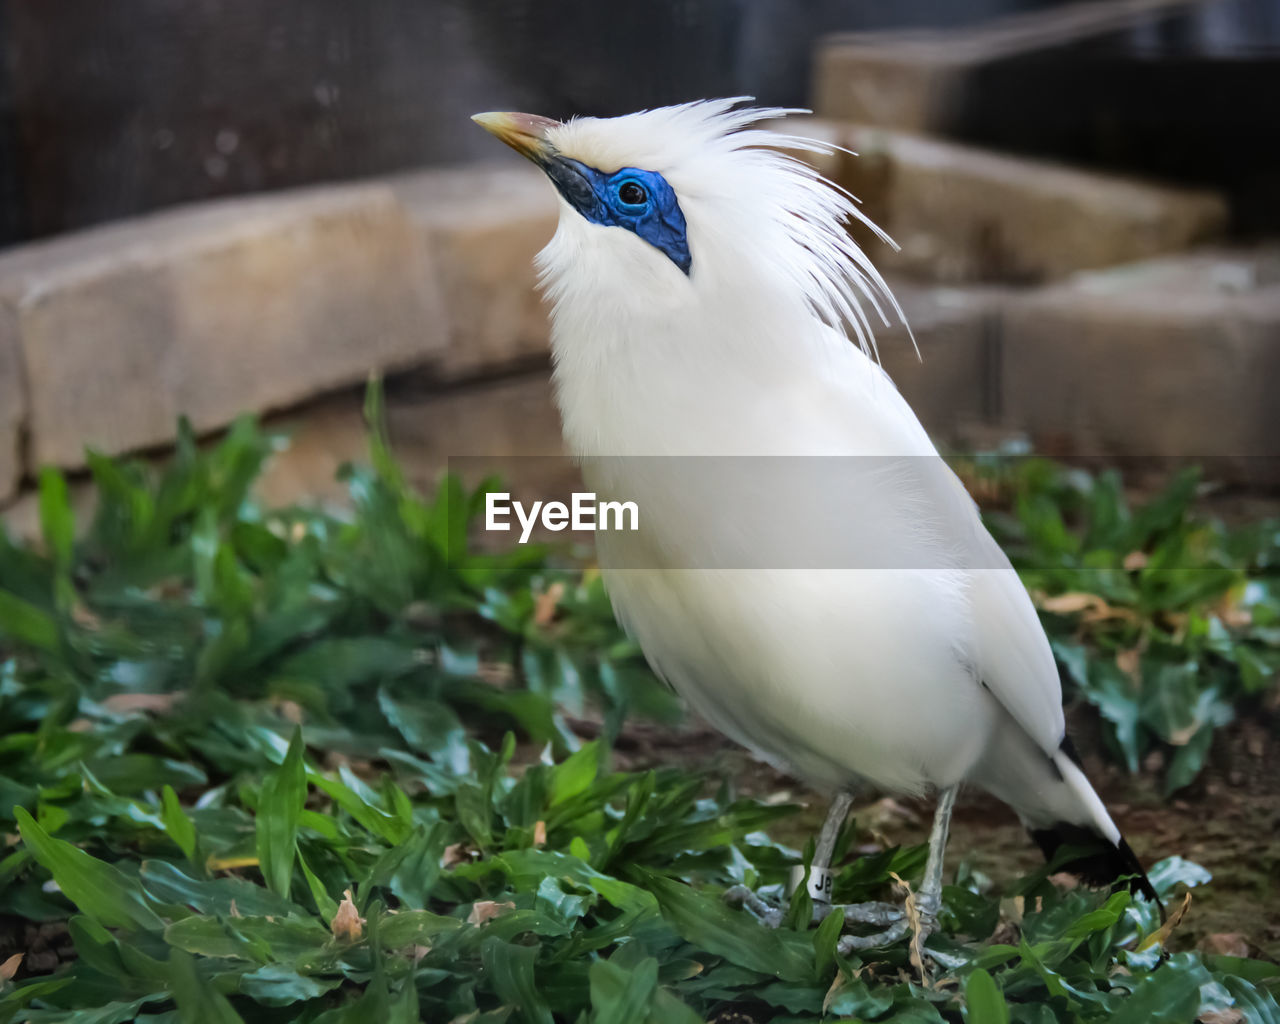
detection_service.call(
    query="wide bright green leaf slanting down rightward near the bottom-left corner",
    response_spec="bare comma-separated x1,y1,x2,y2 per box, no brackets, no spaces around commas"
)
14,808,164,932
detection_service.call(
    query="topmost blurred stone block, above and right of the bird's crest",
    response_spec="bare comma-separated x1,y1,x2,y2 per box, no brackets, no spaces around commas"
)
813,0,1194,134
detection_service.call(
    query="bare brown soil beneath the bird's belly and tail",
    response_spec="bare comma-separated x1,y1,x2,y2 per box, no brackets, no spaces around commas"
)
601,708,1280,961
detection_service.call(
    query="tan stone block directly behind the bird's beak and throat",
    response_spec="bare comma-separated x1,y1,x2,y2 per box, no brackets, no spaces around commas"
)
390,165,557,380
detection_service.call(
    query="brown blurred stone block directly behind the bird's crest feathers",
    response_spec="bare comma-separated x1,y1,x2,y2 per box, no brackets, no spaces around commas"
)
768,122,1228,284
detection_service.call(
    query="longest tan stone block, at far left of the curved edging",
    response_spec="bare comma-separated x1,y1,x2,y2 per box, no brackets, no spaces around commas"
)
0,184,444,468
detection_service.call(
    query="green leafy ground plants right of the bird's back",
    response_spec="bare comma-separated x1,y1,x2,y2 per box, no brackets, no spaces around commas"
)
969,458,1280,792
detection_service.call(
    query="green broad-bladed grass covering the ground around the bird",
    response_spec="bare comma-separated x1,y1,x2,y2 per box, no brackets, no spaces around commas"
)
0,392,1280,1024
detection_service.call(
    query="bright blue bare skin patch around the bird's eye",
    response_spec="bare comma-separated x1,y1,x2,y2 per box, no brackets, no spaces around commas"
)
543,156,692,274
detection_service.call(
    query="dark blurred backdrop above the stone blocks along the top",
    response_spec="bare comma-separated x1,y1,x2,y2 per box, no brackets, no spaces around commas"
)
0,0,1280,246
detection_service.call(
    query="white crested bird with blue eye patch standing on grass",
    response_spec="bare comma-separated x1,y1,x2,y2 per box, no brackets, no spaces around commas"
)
475,100,1155,950
